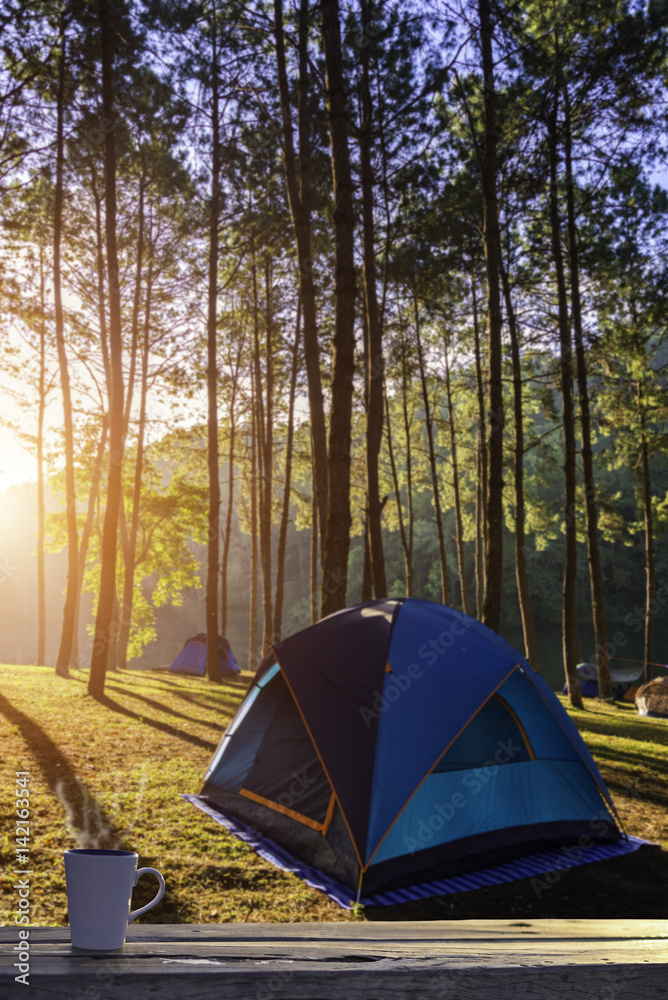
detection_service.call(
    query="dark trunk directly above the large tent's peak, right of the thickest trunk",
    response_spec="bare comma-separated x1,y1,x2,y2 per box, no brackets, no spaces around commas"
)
360,0,387,597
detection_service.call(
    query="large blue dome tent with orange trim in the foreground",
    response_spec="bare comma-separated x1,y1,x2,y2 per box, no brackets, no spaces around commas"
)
186,598,640,906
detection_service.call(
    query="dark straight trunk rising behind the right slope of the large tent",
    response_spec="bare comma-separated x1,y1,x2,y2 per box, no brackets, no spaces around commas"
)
478,0,503,629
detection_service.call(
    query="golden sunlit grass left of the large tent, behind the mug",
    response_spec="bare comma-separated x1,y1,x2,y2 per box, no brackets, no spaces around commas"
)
0,666,349,925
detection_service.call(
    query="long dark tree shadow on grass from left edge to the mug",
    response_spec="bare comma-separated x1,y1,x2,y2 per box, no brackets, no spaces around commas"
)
0,694,120,848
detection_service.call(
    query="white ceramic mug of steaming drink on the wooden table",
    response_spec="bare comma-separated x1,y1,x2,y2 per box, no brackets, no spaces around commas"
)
65,850,165,951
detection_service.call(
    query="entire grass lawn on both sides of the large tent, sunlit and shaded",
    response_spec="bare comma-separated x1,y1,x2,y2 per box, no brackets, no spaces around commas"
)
0,666,668,926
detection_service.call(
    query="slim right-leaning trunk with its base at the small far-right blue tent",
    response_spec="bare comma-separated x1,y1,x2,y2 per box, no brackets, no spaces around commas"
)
564,85,614,701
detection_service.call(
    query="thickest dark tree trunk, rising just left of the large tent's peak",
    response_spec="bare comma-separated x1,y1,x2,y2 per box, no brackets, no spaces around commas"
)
320,0,355,615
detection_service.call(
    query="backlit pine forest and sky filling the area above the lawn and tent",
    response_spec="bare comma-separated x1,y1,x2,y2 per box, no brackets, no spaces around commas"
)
0,0,668,704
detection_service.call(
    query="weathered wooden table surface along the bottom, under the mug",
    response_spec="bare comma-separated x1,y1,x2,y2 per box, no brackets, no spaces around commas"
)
0,920,668,1000
